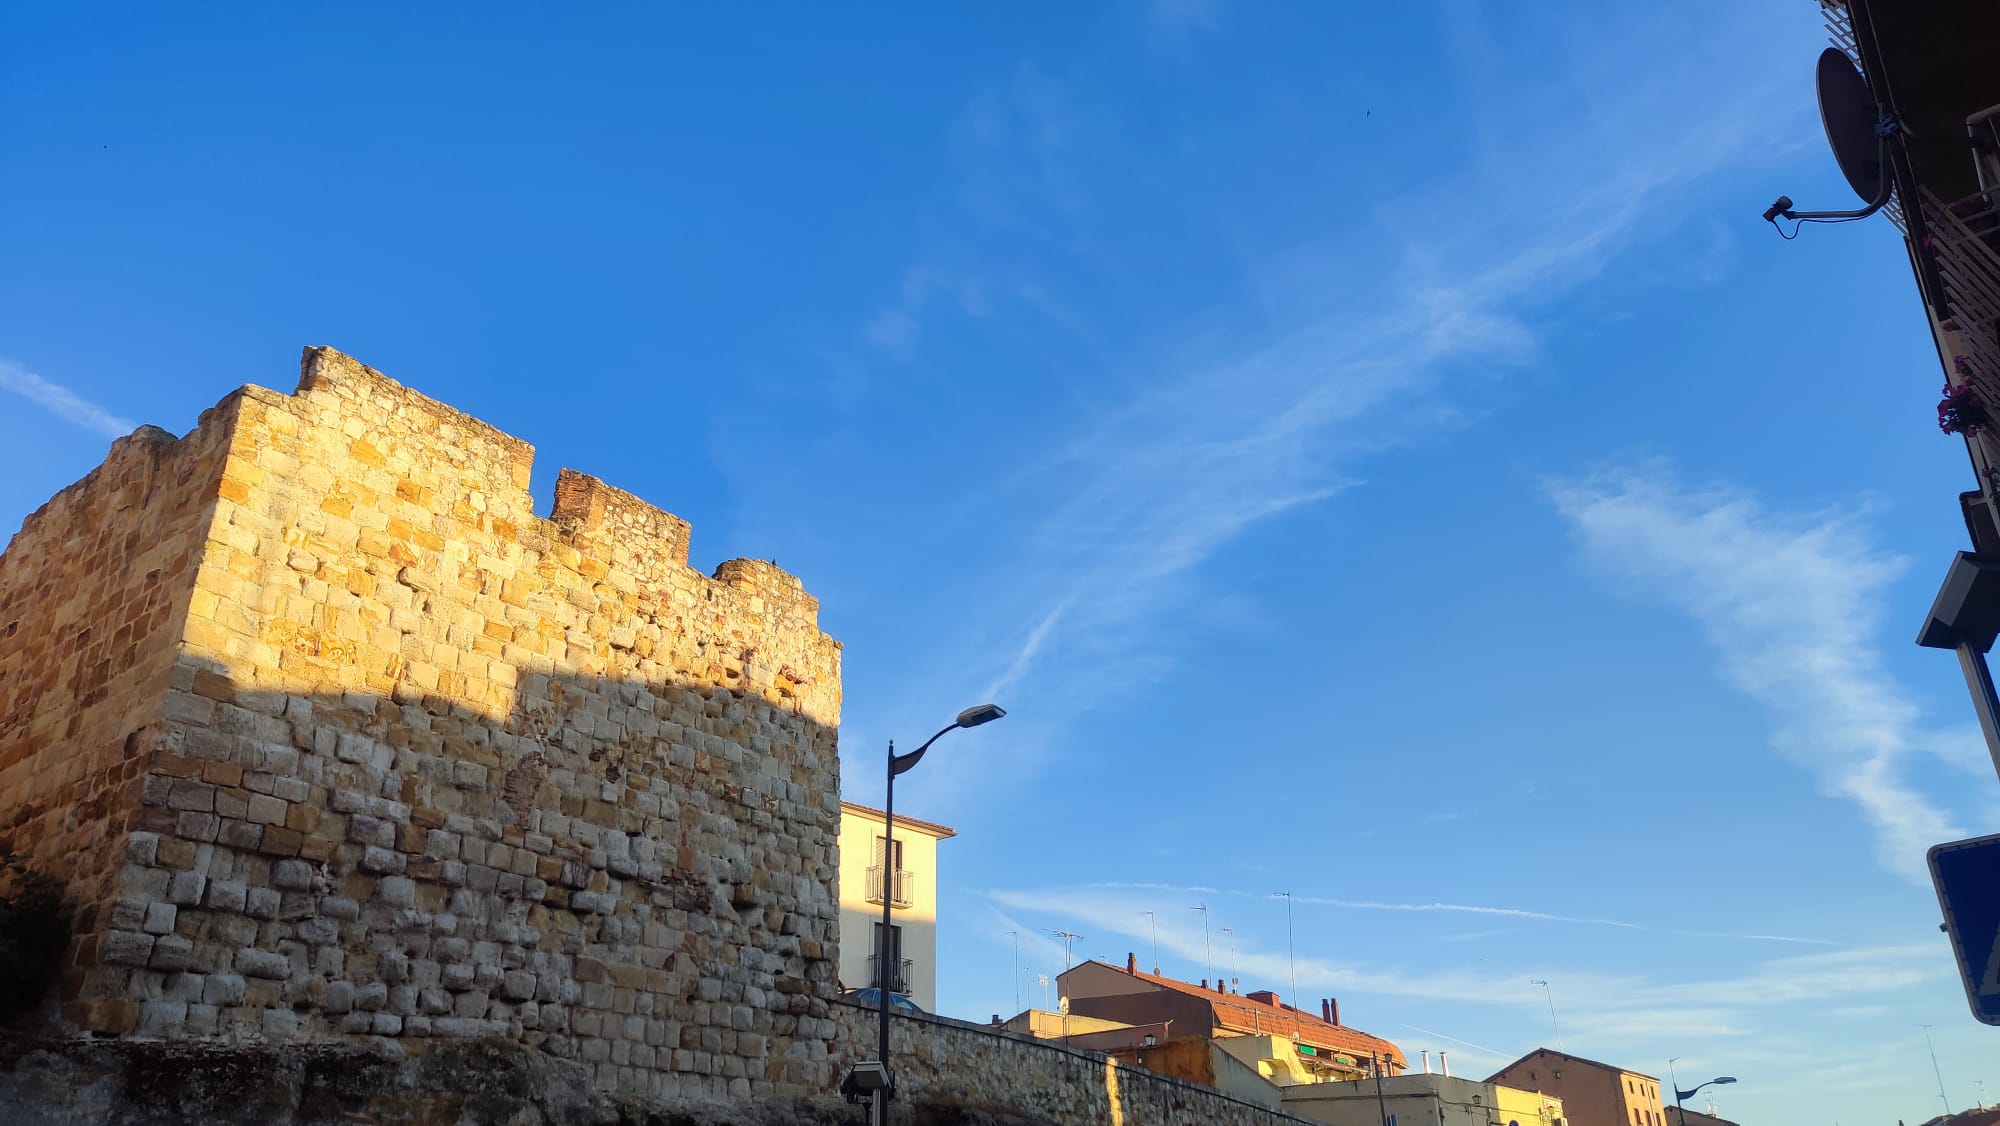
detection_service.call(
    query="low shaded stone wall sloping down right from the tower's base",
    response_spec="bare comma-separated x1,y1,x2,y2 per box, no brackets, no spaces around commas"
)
834,1000,1306,1126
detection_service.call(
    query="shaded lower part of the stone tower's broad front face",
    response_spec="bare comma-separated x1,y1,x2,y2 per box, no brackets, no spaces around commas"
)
66,662,842,1098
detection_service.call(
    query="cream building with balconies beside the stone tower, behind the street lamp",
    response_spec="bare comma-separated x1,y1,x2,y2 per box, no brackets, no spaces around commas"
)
840,802,958,1010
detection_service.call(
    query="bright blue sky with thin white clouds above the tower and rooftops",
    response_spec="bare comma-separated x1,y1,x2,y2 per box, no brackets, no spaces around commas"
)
0,0,2000,1122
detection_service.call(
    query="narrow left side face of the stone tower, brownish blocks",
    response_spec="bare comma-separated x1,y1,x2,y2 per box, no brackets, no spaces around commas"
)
0,408,238,980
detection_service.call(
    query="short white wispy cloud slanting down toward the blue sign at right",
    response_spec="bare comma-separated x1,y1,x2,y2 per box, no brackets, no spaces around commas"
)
1550,462,1964,884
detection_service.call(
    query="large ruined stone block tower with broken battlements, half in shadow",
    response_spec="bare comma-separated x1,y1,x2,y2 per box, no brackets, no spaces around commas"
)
0,348,844,1098
